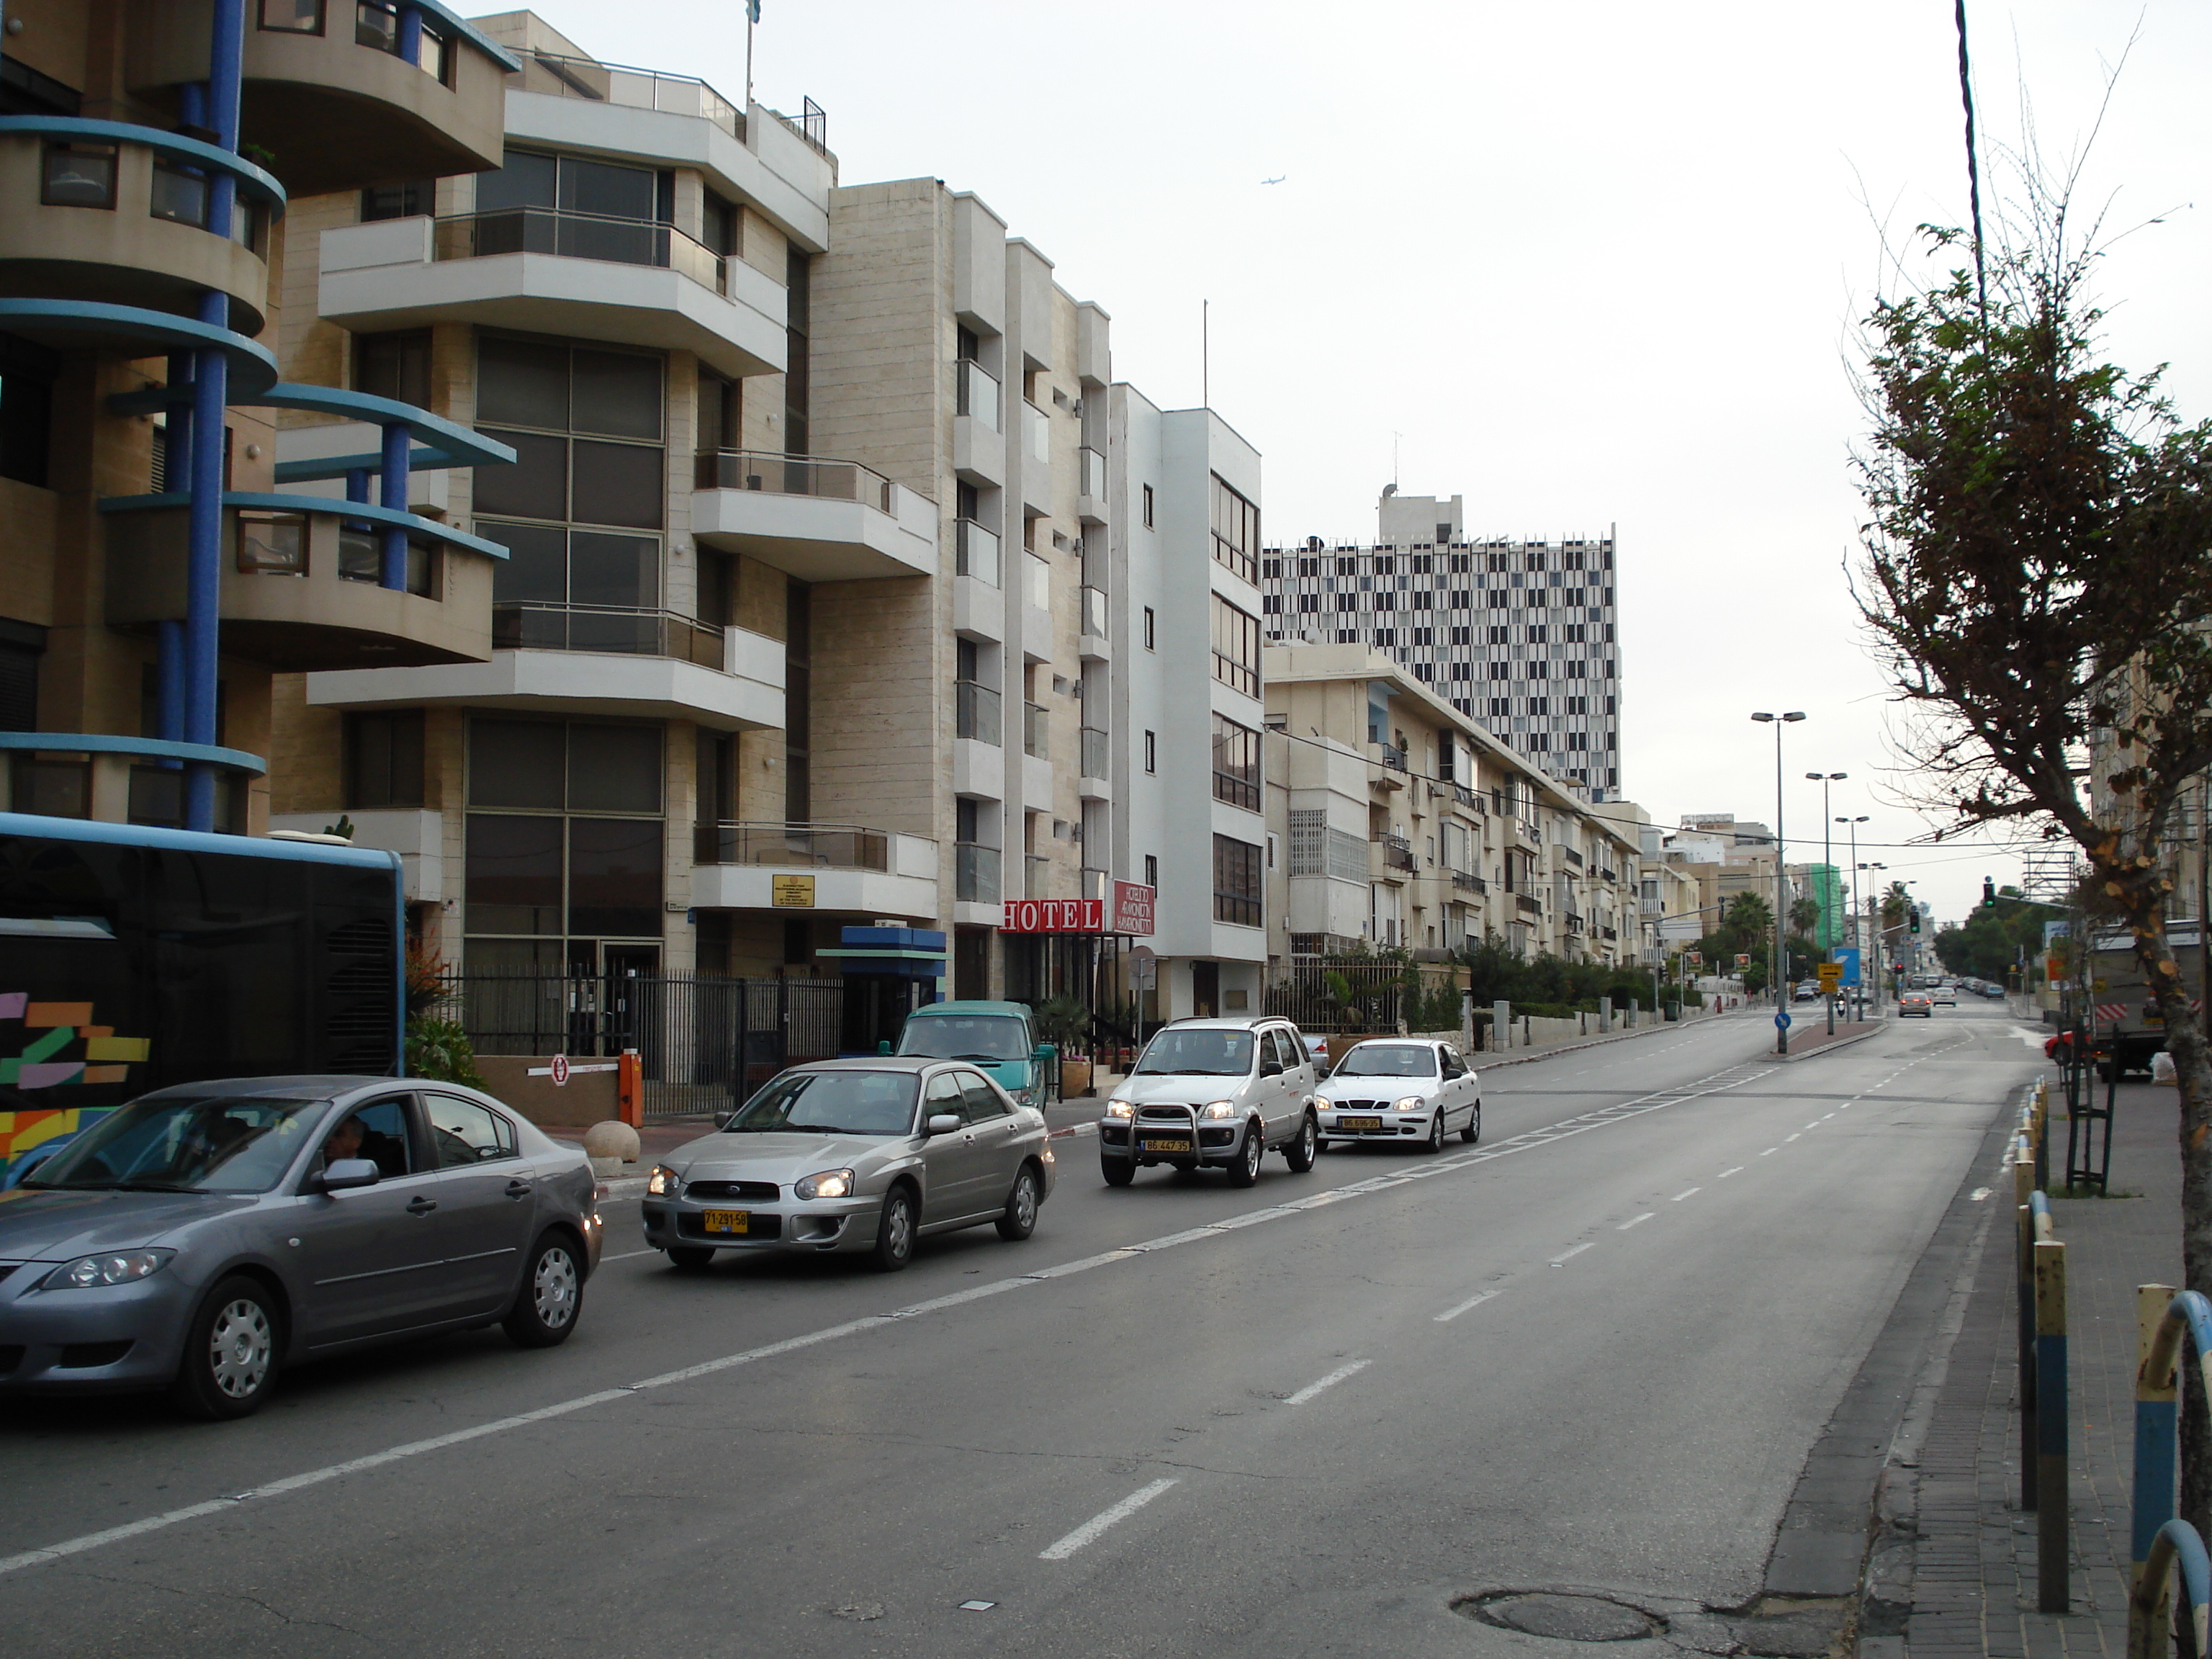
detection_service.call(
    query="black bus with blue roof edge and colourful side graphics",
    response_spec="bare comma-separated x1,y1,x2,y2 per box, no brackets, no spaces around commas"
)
0,811,407,1186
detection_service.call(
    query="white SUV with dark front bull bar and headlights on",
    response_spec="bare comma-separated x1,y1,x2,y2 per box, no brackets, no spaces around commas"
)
1100,1017,1321,1186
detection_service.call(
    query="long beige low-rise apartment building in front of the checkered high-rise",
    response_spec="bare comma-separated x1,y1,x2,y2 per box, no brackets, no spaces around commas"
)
1263,644,1641,964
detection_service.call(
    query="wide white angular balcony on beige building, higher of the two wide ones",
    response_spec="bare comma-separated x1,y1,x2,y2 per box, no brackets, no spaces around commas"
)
318,208,788,378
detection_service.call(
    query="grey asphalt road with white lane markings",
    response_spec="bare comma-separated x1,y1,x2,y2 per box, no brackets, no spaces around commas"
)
0,1004,2041,1659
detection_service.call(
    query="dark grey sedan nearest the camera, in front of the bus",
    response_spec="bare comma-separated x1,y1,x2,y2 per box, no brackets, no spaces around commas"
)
0,1077,602,1418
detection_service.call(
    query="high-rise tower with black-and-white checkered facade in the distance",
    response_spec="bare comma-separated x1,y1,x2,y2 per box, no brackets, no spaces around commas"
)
1261,489,1622,801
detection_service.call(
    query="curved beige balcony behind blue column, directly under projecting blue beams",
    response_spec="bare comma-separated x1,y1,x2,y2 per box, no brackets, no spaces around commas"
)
99,491,506,673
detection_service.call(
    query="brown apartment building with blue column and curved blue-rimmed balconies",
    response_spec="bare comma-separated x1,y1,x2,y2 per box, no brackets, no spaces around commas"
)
0,0,513,832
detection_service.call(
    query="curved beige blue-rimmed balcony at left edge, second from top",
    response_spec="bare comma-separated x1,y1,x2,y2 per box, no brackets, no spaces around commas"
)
0,115,285,334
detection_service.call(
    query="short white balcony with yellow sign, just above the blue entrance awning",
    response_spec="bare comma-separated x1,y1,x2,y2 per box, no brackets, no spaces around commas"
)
690,823,938,918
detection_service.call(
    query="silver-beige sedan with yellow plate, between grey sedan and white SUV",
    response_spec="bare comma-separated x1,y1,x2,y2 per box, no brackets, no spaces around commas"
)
644,1055,1055,1272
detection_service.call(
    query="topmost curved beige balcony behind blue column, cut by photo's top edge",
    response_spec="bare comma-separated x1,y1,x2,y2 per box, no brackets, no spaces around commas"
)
120,0,518,194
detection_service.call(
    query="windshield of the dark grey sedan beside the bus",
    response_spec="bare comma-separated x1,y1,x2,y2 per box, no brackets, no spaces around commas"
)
24,1095,330,1192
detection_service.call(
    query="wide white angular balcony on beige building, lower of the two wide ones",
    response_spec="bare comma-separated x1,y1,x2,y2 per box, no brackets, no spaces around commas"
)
307,604,783,732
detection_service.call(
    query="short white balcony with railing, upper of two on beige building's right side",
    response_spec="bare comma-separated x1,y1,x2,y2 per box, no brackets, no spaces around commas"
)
693,449,938,582
